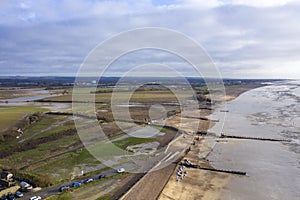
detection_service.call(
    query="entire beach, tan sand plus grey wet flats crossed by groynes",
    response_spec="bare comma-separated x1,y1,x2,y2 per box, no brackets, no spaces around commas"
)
159,82,300,200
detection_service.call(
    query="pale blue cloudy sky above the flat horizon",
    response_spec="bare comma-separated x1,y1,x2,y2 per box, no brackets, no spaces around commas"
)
0,0,300,79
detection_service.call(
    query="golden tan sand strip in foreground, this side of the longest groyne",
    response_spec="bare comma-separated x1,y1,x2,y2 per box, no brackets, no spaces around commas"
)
159,138,233,200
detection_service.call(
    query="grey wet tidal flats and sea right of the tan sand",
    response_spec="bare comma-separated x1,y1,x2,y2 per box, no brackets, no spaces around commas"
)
208,80,300,200
